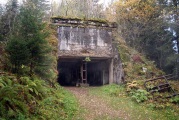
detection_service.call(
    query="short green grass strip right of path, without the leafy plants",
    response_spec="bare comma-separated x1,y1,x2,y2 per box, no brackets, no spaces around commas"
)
90,85,179,120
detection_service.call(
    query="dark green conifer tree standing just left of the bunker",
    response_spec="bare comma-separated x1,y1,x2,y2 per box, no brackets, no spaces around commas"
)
20,6,50,75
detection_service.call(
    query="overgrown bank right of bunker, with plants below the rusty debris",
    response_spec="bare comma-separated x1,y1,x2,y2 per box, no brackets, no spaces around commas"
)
112,34,179,115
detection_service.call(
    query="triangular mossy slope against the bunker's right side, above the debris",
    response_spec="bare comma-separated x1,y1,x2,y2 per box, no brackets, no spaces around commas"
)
114,33,164,81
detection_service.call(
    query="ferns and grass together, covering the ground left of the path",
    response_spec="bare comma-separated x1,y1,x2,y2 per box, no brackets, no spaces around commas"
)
0,75,78,120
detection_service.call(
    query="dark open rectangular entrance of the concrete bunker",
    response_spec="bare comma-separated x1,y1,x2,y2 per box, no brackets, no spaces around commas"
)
58,58,109,86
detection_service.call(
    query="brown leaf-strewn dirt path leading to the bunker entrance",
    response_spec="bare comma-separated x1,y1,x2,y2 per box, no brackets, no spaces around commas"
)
66,87,128,120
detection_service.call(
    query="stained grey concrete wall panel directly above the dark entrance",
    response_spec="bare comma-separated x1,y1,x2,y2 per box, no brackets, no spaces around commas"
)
58,26,112,57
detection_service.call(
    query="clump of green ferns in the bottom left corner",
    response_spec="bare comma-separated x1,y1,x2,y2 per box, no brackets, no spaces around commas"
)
0,76,46,119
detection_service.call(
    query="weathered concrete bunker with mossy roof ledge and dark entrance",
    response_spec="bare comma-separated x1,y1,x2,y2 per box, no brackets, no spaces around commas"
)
52,17,123,86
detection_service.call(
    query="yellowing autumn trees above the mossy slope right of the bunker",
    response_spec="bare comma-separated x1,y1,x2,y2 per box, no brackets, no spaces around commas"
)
114,0,175,73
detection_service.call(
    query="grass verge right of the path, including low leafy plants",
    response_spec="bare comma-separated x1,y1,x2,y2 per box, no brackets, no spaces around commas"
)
91,84,179,120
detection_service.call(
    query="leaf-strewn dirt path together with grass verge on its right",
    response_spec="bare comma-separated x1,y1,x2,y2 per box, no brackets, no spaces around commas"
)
65,86,179,120
